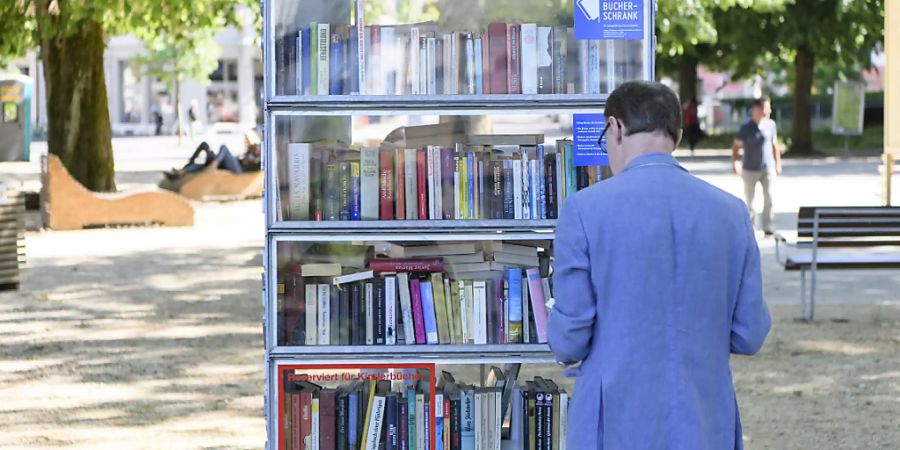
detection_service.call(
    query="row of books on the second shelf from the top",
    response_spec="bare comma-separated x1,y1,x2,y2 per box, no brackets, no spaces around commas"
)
286,140,605,221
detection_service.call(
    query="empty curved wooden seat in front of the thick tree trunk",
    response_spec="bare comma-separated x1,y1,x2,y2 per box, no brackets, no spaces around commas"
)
41,155,194,230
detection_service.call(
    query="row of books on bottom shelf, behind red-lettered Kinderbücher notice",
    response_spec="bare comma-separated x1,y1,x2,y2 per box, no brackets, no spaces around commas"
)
280,368,569,450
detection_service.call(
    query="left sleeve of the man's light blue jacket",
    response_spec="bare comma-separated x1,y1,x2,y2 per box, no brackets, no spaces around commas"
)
547,197,597,363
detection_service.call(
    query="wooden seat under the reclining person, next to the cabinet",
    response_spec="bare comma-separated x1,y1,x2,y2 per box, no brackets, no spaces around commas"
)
178,167,264,200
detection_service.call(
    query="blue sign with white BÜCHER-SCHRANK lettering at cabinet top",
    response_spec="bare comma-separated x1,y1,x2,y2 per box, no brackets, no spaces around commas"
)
575,0,644,40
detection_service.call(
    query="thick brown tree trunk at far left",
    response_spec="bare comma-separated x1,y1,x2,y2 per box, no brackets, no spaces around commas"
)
38,14,116,192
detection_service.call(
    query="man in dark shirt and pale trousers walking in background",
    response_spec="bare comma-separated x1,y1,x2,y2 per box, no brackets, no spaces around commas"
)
731,97,781,236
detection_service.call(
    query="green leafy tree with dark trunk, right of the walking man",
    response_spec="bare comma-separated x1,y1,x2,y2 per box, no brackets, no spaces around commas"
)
719,0,884,155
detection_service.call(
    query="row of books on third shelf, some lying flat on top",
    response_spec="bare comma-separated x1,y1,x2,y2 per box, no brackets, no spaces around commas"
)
278,242,552,346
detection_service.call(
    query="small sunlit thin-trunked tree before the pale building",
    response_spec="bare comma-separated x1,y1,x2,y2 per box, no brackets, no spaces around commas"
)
135,30,219,143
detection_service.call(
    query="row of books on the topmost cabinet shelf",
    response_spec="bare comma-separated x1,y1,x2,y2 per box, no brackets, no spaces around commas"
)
275,22,643,95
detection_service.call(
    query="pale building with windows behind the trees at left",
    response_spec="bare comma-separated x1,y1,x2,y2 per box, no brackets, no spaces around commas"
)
13,19,263,136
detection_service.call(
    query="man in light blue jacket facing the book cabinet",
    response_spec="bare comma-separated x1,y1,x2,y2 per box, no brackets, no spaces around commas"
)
548,82,771,450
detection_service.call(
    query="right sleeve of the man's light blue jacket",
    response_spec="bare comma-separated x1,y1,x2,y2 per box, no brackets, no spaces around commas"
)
731,214,772,355
